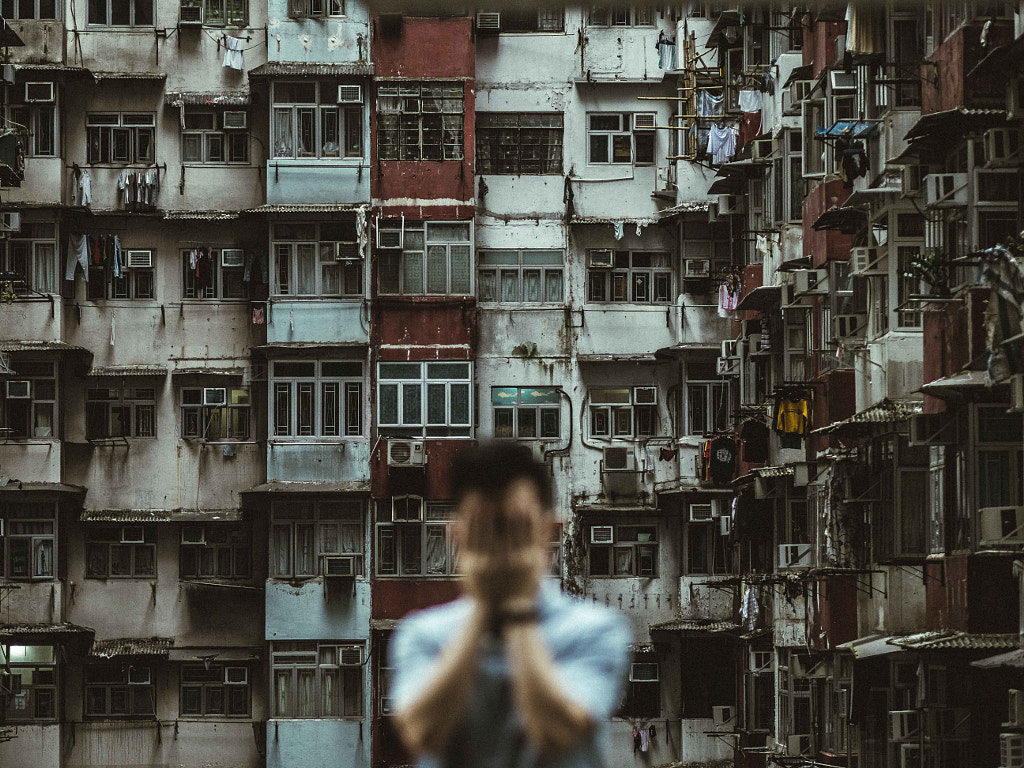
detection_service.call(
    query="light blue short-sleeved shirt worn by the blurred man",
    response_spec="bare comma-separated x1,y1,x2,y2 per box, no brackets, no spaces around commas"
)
389,584,631,768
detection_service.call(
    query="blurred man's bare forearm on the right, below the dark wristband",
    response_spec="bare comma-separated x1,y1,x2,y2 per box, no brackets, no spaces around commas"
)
503,624,593,750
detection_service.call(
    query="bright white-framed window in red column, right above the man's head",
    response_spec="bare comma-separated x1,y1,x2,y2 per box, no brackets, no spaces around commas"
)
377,362,473,437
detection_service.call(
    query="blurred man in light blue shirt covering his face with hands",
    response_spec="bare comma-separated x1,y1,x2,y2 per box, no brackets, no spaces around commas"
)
391,442,630,768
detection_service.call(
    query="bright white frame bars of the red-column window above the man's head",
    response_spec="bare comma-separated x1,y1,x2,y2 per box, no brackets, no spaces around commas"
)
377,360,474,439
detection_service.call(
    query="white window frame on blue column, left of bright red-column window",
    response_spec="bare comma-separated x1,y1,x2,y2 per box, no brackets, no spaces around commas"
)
267,358,366,442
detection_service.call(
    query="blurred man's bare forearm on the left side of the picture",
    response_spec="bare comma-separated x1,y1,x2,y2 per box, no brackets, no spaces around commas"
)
396,607,486,754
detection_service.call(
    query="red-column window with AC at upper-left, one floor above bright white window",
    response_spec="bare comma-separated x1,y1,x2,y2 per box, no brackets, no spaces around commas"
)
377,221,473,296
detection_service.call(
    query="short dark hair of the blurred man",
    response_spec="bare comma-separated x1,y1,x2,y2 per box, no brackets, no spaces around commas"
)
449,440,552,509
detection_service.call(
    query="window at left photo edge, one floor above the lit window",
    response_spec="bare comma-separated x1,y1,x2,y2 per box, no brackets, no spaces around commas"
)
0,503,56,580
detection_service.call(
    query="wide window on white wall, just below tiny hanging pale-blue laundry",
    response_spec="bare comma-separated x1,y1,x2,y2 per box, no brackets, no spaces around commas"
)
587,250,673,304
